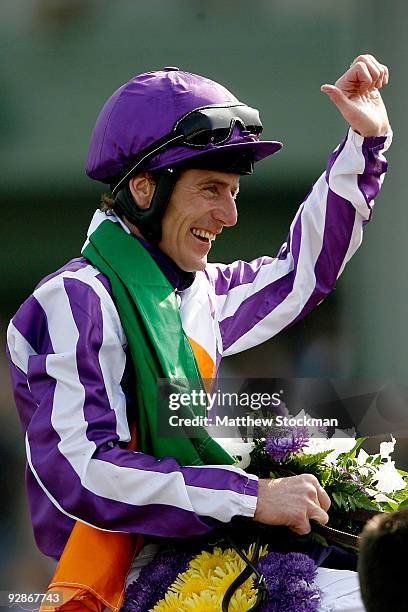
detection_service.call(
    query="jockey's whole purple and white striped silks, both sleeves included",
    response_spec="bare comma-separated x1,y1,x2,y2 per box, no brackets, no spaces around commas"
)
8,130,390,557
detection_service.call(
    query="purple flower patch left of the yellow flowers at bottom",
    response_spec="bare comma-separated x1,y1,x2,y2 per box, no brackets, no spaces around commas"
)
121,549,194,612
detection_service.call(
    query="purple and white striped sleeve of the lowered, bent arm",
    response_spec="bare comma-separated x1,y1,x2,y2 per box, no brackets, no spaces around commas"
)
8,266,257,537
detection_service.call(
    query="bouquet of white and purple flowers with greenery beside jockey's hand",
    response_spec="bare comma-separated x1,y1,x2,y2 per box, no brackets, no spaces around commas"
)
244,413,408,546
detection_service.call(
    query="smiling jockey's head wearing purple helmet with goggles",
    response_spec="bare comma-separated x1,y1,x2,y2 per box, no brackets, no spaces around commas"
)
86,68,282,271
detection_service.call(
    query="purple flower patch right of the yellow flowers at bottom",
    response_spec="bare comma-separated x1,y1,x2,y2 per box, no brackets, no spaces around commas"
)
259,552,320,612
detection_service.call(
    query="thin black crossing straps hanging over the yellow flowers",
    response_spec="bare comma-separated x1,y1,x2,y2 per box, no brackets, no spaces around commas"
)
221,529,268,612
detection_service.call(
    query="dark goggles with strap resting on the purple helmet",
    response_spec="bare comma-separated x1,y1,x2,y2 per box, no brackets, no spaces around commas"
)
112,104,262,195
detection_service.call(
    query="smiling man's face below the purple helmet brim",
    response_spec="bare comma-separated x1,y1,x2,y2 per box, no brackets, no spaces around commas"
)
159,170,239,272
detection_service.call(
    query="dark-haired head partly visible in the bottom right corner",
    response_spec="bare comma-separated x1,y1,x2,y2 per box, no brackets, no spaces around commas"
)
358,508,408,612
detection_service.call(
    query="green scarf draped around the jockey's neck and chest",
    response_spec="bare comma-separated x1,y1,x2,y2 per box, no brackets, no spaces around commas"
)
83,220,234,465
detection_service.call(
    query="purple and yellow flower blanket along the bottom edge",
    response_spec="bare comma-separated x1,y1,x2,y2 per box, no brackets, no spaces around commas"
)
123,545,320,612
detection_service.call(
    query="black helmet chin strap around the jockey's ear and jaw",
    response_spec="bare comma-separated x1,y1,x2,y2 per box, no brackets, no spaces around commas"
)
115,168,177,244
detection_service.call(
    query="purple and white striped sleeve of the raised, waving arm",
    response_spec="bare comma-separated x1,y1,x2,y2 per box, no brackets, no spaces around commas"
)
206,129,391,355
